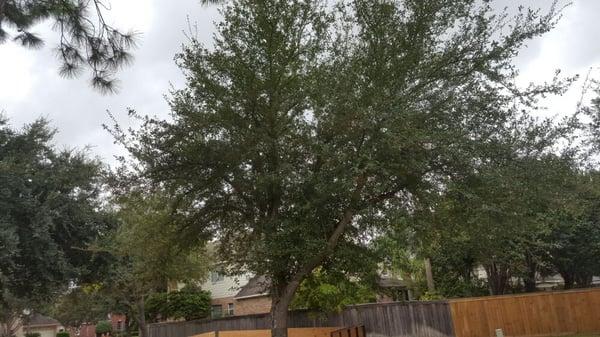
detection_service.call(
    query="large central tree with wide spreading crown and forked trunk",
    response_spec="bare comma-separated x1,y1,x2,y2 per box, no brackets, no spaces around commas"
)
113,0,561,337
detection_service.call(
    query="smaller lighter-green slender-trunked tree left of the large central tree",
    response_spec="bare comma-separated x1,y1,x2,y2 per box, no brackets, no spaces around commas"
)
99,189,209,337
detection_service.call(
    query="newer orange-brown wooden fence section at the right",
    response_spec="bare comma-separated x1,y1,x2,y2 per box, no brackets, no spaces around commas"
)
450,289,600,337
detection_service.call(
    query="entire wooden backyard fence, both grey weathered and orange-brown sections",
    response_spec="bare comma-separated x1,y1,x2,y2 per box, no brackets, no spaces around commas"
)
149,288,600,337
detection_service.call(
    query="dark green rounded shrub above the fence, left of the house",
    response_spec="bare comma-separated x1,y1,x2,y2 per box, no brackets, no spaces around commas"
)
146,285,210,322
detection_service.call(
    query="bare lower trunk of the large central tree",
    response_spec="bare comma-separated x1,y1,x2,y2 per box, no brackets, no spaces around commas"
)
270,276,304,337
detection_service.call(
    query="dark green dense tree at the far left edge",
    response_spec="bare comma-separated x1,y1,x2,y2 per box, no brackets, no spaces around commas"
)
0,119,113,336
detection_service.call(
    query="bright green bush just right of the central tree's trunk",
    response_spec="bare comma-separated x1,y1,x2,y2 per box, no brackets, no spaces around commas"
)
292,269,376,312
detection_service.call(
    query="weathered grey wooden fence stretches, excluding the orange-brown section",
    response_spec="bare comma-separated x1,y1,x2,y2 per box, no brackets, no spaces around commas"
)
148,301,453,337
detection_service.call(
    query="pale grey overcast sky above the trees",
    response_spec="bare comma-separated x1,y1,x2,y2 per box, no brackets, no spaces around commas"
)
0,0,600,166
